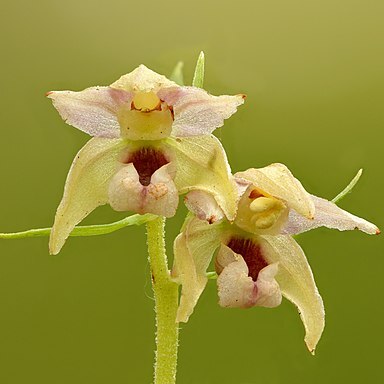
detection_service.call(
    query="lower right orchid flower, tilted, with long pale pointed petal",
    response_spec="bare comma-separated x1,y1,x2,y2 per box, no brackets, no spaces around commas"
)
173,164,380,353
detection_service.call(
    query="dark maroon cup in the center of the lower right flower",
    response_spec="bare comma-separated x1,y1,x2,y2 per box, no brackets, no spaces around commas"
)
227,237,268,281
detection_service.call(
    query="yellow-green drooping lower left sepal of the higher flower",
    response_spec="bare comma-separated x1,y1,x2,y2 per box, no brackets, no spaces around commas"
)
49,138,125,255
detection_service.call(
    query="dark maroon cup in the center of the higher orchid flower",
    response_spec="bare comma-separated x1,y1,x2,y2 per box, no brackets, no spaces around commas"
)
124,147,169,186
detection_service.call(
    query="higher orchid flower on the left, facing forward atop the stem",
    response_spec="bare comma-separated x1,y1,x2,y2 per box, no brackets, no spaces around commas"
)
48,65,244,254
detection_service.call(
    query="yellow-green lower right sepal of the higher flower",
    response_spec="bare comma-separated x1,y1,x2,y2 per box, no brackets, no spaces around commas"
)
166,135,238,220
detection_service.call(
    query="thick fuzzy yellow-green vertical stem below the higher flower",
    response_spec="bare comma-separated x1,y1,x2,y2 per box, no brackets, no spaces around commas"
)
146,217,179,384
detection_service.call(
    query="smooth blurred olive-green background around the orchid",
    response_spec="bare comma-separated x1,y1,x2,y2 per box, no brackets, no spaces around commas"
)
0,0,384,384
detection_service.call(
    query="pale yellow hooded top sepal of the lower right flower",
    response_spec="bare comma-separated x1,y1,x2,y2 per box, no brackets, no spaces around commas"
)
235,163,315,219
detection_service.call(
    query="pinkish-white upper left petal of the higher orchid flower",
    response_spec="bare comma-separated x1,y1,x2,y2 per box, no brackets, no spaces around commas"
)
47,87,132,138
